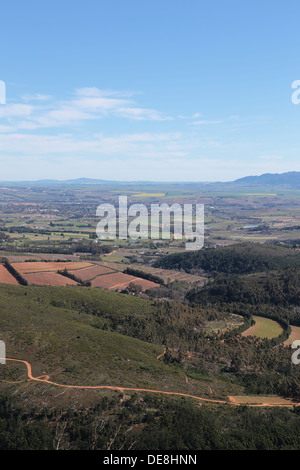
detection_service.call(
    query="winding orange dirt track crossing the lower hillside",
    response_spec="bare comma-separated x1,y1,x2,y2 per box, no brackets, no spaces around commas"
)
0,357,297,408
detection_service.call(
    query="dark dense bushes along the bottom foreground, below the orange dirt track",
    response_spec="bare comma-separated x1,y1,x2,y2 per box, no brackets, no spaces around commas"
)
0,394,300,451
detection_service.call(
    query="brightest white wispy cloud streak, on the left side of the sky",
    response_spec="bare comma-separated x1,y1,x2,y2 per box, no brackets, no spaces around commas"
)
0,87,172,132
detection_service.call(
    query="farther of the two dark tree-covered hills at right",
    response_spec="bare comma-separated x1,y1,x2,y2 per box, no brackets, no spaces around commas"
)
154,243,300,274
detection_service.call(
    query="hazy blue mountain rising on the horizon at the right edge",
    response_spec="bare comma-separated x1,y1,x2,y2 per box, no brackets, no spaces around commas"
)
234,171,300,187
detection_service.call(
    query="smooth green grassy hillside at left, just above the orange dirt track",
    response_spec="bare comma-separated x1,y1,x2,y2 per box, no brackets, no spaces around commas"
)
0,285,241,396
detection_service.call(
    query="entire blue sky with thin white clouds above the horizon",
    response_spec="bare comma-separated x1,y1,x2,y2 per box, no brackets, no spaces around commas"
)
0,0,300,182
